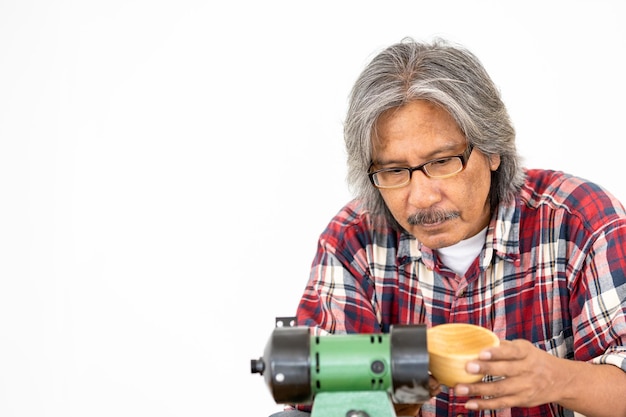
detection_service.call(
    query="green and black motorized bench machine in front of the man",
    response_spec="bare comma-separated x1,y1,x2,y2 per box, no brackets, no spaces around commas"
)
251,325,430,417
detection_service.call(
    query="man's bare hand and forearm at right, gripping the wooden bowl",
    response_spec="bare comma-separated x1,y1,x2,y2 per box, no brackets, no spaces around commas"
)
454,340,626,417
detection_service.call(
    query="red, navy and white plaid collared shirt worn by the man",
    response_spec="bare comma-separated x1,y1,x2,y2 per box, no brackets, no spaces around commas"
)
297,170,626,417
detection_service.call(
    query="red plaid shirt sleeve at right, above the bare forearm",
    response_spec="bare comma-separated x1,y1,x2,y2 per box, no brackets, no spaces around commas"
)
570,182,626,371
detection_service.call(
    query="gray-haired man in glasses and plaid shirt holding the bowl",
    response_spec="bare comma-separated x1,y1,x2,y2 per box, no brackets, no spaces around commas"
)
272,39,626,417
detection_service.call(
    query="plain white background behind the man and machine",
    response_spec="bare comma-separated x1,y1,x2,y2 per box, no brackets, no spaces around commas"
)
0,0,626,417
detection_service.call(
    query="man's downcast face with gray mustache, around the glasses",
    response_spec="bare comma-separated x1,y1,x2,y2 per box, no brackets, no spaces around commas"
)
372,100,500,249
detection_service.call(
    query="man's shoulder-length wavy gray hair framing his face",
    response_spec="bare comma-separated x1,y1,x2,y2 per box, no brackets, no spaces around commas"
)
344,38,524,227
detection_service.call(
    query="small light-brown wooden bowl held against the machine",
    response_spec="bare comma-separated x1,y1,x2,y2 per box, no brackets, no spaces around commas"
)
426,323,500,387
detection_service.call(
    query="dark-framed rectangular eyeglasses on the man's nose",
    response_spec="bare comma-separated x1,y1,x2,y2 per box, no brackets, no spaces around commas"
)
367,144,474,188
